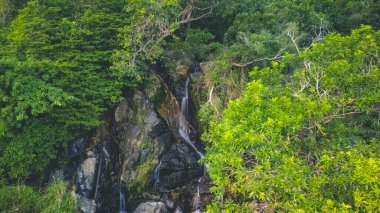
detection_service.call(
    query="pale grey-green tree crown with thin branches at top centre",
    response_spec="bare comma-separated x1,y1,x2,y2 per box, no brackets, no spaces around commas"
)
114,0,182,80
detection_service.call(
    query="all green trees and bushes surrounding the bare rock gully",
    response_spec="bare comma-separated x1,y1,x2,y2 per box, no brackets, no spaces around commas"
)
0,0,380,212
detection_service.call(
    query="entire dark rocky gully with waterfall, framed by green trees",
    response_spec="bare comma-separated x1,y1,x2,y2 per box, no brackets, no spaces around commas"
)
64,67,209,213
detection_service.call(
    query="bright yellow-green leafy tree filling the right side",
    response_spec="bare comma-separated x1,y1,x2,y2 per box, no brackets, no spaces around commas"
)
204,26,380,212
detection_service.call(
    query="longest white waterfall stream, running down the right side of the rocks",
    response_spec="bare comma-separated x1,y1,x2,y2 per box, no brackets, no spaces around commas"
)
178,77,206,210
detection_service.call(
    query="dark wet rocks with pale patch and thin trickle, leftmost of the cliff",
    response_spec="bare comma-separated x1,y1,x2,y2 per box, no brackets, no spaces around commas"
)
61,125,120,213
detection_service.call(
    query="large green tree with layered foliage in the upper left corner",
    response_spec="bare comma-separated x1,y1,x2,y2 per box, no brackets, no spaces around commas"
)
2,1,124,127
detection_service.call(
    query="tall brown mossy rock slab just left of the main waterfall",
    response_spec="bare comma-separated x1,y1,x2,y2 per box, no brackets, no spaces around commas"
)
113,91,174,190
